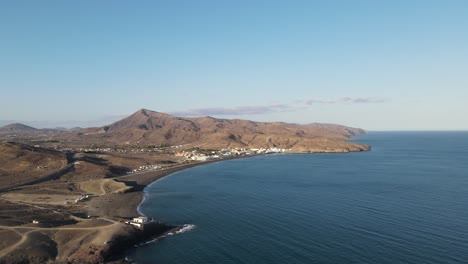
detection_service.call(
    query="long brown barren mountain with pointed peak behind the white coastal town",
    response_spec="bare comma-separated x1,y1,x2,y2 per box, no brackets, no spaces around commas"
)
80,109,369,152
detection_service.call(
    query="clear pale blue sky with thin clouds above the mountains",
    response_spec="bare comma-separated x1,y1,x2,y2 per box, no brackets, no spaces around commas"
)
0,0,468,130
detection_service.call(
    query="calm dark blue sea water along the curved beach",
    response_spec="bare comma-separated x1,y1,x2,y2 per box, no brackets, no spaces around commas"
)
129,132,468,264
